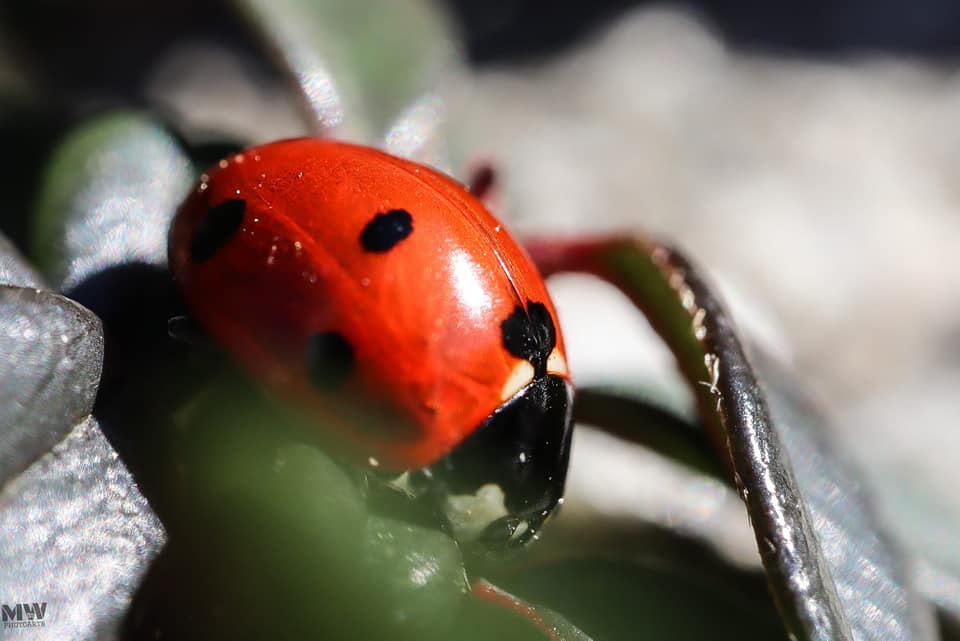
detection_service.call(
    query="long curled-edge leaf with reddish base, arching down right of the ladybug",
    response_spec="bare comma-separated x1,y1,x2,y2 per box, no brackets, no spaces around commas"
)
528,238,936,641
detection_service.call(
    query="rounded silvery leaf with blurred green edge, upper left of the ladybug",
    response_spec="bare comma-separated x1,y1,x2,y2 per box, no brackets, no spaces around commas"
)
33,113,194,291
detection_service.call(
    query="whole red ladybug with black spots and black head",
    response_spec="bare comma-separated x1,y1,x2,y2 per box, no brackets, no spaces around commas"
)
169,138,573,546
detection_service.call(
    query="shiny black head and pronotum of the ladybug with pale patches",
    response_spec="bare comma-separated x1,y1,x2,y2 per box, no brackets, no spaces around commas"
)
418,374,573,550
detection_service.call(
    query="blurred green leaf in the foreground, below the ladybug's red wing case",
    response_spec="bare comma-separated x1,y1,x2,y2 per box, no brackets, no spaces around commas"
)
142,376,467,639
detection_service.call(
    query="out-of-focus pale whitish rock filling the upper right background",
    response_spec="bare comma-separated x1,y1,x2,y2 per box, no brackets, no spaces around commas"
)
451,9,960,568
